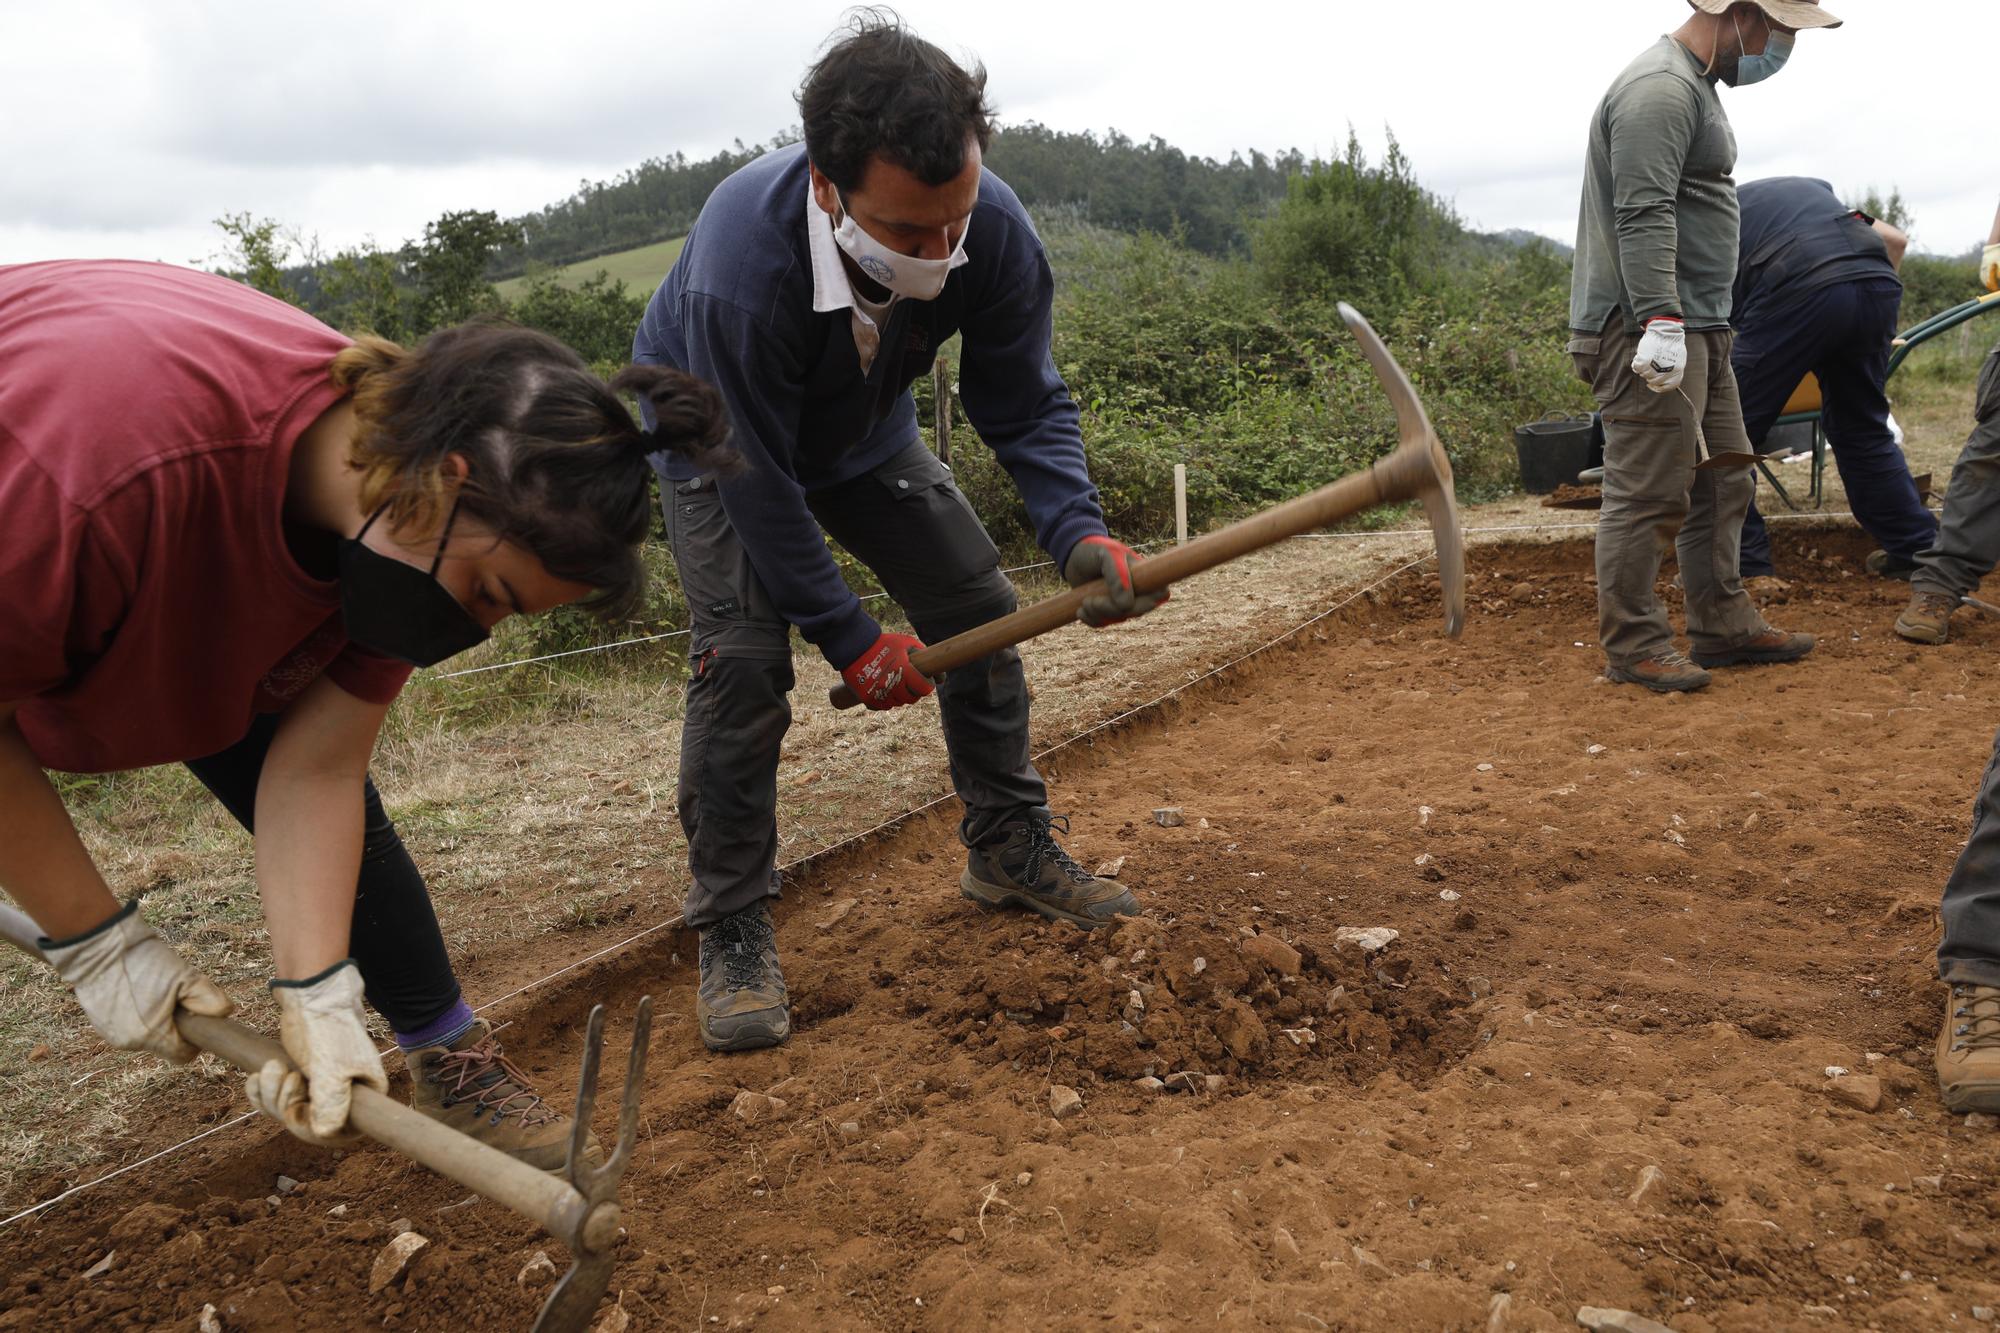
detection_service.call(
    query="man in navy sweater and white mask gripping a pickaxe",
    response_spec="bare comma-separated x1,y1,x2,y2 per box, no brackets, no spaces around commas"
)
632,12,1164,1051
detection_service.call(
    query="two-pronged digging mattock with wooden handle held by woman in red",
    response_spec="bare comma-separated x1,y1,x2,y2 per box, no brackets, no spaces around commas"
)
0,907,652,1333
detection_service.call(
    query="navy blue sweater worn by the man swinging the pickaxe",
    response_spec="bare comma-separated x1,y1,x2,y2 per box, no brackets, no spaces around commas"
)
632,144,1104,667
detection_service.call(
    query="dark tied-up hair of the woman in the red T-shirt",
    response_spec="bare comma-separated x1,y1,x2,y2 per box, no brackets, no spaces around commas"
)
332,320,740,618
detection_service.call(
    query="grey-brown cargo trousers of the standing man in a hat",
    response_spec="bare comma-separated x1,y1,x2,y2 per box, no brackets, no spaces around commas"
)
1568,314,1764,667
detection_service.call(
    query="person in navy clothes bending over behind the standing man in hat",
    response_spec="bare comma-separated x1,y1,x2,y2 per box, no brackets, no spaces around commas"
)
1730,176,1938,578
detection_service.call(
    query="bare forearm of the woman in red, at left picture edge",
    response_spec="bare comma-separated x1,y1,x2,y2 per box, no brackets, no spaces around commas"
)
0,705,118,939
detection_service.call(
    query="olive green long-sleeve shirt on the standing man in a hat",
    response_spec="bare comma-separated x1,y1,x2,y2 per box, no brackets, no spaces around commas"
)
1570,36,1738,334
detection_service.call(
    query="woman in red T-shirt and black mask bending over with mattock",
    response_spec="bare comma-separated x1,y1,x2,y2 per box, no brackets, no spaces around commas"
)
0,262,722,1169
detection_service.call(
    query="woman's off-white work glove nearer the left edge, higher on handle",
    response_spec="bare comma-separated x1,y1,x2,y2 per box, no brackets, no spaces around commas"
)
38,899,236,1065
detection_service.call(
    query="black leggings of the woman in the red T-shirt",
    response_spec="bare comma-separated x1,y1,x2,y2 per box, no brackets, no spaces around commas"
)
188,713,458,1033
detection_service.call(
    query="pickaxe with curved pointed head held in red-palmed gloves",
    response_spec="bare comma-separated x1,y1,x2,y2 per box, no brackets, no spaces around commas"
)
828,302,1466,709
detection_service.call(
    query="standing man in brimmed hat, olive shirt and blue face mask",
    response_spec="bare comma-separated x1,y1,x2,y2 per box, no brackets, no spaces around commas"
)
1568,0,1840,693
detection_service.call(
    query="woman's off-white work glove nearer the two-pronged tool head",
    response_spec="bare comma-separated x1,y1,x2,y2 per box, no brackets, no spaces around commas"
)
244,959,388,1147
